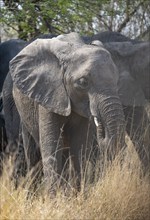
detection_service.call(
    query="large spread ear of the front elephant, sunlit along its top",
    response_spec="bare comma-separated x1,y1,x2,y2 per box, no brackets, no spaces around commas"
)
10,38,71,116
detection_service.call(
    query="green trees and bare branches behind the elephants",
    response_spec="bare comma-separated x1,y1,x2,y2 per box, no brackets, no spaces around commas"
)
0,0,150,40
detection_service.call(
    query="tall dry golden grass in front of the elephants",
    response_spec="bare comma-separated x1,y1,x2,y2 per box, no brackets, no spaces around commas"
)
0,138,150,220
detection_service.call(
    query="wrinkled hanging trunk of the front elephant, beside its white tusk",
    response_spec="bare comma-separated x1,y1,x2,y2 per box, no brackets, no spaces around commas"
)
93,96,125,159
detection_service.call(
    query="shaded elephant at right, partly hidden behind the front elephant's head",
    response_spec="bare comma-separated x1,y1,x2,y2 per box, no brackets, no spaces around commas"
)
102,42,150,171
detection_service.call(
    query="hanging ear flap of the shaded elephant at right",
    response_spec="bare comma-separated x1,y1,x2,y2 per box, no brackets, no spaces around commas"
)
118,71,146,106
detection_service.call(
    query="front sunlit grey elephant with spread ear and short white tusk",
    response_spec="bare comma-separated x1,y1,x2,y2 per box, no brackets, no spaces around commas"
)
10,33,125,192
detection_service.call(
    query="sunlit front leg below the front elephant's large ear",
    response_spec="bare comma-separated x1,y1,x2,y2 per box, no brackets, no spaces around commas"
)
39,106,66,194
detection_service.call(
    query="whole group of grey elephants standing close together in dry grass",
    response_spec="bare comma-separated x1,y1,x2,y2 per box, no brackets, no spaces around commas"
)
0,31,150,194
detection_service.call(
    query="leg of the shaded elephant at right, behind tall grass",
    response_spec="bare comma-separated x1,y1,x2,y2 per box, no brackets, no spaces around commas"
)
124,106,150,172
